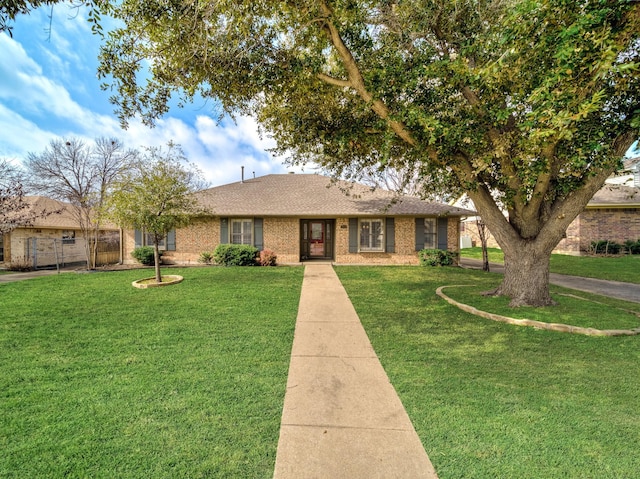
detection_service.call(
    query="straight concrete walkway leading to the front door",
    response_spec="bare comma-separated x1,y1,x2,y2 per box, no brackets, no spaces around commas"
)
274,264,437,479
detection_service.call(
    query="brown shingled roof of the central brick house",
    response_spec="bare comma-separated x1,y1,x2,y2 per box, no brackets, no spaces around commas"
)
198,174,476,217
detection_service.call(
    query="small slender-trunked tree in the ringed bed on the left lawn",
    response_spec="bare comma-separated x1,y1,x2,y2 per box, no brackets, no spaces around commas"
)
110,143,203,283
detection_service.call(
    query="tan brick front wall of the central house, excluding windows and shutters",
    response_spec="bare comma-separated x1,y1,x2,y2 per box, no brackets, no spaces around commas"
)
123,217,460,264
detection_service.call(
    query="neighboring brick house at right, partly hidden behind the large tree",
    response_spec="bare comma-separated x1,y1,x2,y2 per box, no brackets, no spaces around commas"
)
461,158,640,254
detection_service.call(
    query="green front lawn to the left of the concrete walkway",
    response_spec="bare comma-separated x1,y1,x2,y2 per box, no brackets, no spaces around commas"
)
0,268,302,478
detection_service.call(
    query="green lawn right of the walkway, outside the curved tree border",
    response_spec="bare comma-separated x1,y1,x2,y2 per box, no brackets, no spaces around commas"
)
337,267,640,479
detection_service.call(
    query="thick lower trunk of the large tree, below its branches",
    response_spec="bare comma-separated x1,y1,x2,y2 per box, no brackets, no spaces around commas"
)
495,245,555,307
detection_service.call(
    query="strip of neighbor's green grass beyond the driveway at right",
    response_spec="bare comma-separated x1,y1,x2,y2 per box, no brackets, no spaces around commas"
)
460,247,640,284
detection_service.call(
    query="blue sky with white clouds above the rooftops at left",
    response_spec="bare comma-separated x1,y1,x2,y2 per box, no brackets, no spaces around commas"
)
0,4,314,186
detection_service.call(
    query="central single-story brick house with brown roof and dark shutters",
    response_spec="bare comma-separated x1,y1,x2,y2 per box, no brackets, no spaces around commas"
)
123,174,475,264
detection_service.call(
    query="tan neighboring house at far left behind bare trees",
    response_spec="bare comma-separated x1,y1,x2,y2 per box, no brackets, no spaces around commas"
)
0,196,120,268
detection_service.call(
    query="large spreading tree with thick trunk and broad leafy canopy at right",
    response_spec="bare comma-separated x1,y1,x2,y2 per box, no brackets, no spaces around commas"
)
2,0,640,305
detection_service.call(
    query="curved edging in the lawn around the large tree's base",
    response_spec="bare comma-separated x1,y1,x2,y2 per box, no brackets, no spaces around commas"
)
436,284,640,336
